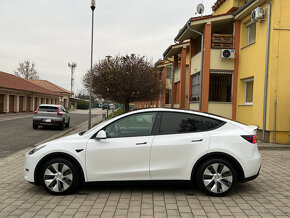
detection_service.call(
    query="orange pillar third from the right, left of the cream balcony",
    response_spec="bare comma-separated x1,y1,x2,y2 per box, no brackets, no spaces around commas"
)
179,46,186,109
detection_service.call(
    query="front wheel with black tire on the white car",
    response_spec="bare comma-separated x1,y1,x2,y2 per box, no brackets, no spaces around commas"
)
39,158,80,195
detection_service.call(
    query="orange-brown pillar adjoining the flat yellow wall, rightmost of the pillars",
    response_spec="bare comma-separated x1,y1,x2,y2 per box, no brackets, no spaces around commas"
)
232,20,241,120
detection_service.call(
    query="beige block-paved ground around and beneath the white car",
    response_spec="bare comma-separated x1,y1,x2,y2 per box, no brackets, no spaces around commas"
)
0,150,290,218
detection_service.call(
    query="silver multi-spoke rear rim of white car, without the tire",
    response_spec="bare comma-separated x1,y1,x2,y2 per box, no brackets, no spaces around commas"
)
202,163,233,194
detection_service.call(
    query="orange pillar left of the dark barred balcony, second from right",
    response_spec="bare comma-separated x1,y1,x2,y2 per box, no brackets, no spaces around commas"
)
201,24,211,112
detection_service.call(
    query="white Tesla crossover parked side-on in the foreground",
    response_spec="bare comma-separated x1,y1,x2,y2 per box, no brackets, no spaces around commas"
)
25,108,261,196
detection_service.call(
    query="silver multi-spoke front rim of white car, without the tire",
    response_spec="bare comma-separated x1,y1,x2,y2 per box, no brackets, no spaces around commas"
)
44,163,73,193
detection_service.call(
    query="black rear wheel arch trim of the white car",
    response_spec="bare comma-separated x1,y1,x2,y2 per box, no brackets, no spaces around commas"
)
191,152,245,182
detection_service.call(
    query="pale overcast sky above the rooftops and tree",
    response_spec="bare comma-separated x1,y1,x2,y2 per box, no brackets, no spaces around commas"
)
0,0,216,92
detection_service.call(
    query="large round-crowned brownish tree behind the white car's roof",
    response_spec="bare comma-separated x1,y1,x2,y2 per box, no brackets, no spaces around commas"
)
83,54,165,112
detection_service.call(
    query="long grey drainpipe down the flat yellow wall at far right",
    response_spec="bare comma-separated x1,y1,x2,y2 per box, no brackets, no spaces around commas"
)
263,0,271,142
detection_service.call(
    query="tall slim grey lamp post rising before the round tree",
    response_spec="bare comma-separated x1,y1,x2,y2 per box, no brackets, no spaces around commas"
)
88,0,96,129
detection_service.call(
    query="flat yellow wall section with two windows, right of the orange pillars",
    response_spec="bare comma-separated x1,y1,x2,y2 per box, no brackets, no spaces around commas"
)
228,0,290,144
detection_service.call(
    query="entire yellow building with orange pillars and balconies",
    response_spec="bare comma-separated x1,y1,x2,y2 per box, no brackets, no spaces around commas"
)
138,0,290,144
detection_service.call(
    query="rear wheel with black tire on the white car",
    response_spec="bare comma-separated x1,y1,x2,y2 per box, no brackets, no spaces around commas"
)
196,158,237,197
